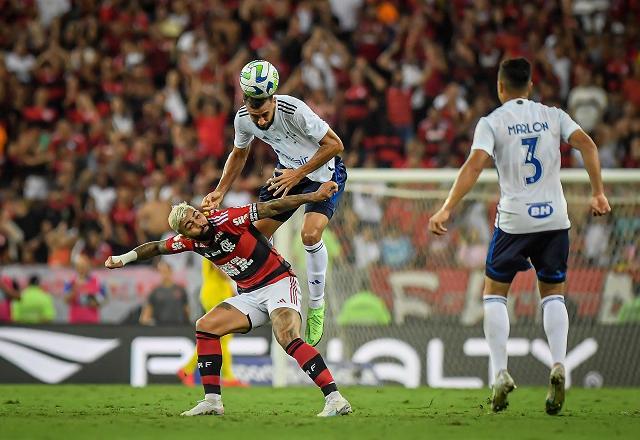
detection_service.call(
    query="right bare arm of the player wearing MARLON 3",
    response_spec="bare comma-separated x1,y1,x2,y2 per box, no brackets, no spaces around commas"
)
569,129,611,216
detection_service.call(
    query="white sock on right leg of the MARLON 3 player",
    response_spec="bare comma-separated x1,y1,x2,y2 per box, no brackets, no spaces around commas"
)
542,295,569,364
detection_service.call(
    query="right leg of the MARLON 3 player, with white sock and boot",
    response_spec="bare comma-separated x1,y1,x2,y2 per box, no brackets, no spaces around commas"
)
538,281,569,415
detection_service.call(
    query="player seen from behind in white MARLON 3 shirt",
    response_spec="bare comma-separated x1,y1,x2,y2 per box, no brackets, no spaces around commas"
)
429,58,611,414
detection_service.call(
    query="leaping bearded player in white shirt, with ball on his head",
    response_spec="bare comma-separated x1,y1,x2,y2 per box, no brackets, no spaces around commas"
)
202,60,347,346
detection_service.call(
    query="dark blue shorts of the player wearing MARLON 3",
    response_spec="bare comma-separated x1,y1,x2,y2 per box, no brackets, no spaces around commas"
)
485,227,569,284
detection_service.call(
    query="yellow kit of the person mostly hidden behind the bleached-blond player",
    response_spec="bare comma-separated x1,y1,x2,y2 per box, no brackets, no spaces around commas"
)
182,258,235,380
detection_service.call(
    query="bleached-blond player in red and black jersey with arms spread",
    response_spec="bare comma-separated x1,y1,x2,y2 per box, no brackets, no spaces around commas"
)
104,182,351,417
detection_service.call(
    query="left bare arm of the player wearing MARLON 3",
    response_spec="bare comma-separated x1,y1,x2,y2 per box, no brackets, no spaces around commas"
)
429,150,491,235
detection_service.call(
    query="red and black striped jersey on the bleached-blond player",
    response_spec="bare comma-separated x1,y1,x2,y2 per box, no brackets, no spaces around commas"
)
165,203,295,293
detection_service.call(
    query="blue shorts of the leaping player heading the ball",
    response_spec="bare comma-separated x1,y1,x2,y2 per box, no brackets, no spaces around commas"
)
259,157,347,223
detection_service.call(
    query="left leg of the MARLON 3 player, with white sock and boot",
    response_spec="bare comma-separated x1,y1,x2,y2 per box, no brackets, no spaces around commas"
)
483,277,516,412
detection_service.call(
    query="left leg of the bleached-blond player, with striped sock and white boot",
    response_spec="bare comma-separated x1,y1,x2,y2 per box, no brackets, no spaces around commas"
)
180,302,251,416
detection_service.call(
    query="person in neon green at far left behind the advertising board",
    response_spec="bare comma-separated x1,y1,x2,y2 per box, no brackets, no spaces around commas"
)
11,275,56,324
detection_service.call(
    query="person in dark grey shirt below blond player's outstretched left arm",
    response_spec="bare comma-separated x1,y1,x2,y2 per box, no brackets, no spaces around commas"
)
140,261,189,325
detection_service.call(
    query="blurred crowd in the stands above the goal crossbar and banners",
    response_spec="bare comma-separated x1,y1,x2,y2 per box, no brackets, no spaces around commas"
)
0,0,640,266
